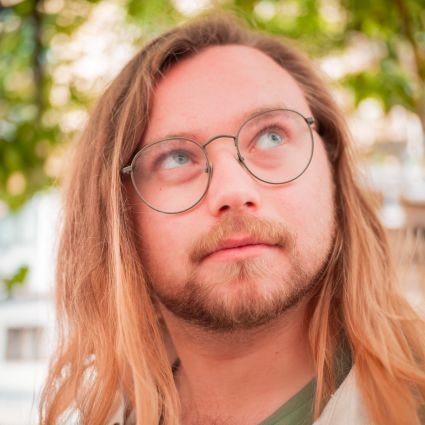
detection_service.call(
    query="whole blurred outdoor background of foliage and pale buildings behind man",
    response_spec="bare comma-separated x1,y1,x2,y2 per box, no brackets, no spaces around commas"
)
0,0,425,425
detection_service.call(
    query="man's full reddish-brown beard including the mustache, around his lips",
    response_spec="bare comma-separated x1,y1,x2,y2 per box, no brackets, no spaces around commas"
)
146,215,334,332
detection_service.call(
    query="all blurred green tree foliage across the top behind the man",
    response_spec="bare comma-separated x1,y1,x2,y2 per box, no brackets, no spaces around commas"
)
0,0,425,209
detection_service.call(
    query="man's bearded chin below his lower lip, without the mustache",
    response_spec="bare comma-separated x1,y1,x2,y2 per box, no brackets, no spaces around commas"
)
157,264,314,332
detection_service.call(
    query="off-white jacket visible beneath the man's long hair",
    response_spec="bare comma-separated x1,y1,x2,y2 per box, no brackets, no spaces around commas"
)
106,369,370,425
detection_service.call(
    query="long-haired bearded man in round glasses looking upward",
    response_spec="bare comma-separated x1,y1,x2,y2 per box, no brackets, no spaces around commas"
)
41,13,425,425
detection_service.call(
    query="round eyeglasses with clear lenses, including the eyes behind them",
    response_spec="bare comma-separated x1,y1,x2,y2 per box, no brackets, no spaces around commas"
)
122,109,314,214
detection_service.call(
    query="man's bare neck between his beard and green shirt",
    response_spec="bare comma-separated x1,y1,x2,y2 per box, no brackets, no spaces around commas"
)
163,303,314,425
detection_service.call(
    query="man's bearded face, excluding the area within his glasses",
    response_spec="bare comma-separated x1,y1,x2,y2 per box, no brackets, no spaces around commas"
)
134,45,334,331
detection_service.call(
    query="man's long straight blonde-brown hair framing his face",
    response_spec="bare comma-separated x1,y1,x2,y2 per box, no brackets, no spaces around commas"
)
40,16,425,425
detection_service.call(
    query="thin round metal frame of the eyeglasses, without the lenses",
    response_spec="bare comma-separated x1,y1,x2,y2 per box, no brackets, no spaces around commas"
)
121,108,315,214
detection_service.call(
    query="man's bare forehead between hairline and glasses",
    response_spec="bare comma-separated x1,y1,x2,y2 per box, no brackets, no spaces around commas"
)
146,45,310,139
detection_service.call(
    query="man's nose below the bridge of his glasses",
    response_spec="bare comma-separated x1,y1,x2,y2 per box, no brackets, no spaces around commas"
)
207,146,261,217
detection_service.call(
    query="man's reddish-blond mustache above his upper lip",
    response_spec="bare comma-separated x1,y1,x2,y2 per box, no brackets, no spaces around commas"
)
189,215,295,263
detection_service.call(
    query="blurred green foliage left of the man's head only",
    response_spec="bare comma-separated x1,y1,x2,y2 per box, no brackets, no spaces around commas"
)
0,0,101,209
